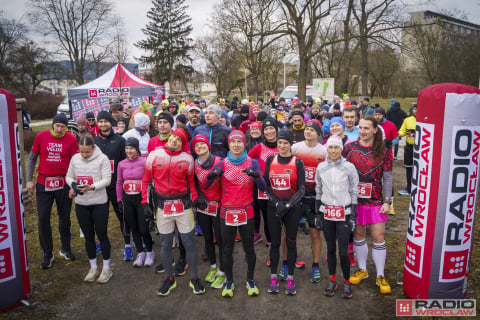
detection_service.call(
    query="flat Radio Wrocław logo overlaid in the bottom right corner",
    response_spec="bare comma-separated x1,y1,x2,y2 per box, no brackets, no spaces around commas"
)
396,299,477,317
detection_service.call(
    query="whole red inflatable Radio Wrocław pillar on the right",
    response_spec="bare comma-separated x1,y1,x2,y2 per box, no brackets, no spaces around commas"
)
403,83,480,299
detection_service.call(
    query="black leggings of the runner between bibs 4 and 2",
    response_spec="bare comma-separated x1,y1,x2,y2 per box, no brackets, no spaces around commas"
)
197,208,224,271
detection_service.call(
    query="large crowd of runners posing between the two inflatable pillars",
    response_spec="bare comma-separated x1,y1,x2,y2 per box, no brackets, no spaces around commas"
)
27,94,416,299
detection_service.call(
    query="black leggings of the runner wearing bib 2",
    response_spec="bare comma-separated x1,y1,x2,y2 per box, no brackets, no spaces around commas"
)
220,218,257,281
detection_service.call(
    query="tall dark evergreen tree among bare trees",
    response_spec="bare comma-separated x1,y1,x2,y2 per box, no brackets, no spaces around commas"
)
135,0,193,90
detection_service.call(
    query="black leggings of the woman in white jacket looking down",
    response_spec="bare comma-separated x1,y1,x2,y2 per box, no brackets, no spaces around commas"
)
75,202,110,260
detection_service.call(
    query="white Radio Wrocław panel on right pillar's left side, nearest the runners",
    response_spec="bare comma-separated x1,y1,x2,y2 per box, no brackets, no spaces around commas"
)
405,122,435,277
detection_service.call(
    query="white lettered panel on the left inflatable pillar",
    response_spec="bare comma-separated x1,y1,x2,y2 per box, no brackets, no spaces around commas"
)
0,124,16,283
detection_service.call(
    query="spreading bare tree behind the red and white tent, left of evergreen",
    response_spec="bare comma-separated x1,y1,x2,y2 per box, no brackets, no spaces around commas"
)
29,0,120,84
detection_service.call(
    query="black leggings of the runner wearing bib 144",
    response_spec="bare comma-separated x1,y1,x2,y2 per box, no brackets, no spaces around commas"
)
268,204,303,276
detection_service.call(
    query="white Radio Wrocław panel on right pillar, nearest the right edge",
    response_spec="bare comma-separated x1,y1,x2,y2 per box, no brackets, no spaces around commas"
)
439,126,480,282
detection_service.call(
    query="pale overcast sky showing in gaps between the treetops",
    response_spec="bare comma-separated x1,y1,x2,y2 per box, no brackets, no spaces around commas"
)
0,0,480,62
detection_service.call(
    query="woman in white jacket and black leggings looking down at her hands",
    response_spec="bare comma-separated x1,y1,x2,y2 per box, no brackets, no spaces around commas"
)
66,136,112,283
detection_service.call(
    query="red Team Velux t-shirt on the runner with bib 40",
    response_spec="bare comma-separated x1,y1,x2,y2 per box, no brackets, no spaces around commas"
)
32,130,78,185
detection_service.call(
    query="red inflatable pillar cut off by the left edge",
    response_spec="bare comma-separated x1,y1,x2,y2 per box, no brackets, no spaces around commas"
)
0,89,30,311
